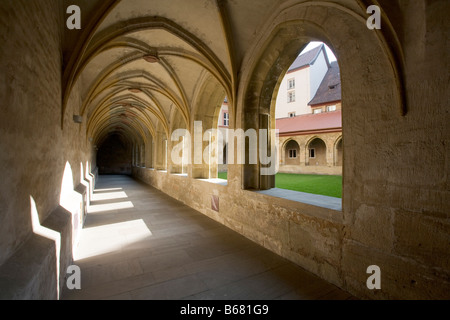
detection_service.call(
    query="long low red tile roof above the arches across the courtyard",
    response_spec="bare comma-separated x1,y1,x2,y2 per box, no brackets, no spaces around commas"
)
276,110,342,135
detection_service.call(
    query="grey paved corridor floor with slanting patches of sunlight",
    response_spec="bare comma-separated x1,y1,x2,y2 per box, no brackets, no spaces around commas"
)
62,176,353,300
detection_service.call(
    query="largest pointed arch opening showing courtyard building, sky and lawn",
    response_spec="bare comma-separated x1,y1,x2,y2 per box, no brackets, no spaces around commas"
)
272,42,343,198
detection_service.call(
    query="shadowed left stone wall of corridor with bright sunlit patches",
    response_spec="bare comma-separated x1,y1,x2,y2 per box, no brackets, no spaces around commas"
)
0,0,95,299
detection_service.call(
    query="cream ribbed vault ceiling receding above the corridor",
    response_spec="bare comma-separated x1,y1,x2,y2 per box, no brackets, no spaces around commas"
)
63,0,282,144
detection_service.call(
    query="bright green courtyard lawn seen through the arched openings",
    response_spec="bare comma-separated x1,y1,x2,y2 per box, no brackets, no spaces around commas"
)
219,172,342,198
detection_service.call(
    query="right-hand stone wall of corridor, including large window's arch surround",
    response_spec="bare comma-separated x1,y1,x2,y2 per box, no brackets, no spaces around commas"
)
134,1,450,299
